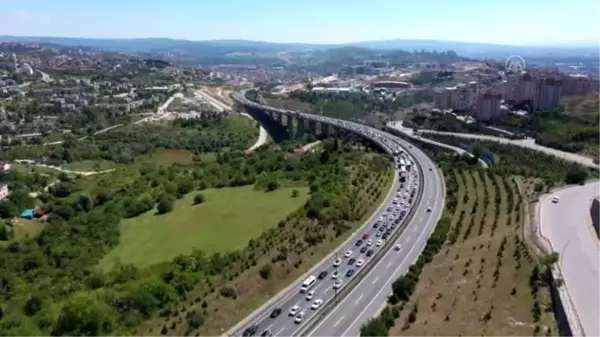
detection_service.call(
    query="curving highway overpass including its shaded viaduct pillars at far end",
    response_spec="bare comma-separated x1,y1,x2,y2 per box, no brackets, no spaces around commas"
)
230,90,445,337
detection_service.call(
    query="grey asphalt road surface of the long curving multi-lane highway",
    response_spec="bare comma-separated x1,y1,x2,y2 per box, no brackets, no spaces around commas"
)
224,89,444,337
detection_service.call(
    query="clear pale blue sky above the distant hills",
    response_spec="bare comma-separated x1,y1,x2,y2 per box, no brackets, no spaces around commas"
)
0,0,600,44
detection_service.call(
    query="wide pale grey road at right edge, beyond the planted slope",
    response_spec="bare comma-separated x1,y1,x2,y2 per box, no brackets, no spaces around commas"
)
539,182,600,337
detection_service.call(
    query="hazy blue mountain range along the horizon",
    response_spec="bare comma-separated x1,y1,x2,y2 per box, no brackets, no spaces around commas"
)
0,36,600,60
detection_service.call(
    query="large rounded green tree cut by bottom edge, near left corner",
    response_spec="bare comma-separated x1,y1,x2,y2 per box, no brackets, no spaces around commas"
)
52,294,116,337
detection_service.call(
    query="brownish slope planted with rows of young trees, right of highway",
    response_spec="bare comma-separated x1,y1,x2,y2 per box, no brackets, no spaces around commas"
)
390,171,558,337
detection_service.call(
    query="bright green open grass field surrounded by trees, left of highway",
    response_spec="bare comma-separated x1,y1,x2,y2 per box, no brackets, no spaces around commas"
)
100,186,308,269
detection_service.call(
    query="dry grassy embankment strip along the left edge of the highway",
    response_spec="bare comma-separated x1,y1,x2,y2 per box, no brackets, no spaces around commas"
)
137,156,393,337
